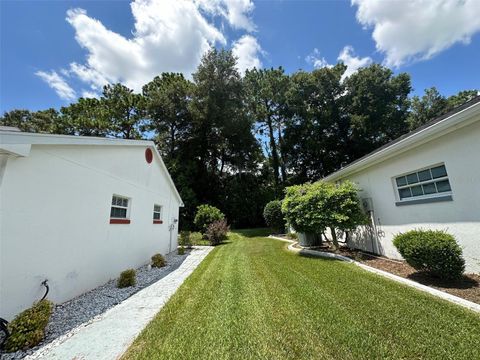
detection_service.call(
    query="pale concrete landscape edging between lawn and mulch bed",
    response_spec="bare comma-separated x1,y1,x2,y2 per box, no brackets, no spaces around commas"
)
269,235,480,314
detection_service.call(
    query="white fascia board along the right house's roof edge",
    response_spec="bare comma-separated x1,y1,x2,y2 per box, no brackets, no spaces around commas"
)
322,103,480,181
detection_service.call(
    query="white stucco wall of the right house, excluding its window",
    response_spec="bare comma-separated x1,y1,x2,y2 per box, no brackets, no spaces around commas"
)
346,119,480,272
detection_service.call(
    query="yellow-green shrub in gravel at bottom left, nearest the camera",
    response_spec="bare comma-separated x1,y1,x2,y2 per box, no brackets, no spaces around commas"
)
4,300,53,352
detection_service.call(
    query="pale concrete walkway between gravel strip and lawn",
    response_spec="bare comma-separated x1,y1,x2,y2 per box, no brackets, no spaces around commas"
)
26,246,213,360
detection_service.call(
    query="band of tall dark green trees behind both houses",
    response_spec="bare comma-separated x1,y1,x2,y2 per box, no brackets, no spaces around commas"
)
0,48,478,228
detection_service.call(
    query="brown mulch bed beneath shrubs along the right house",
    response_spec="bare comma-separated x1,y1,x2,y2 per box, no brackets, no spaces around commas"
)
284,239,480,304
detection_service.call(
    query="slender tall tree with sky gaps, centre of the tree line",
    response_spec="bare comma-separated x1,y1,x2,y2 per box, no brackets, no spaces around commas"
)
244,67,289,192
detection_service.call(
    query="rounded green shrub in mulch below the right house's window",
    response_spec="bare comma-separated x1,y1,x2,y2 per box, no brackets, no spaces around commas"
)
393,230,465,279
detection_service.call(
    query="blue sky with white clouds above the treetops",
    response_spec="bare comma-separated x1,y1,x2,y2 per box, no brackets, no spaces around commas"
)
0,0,480,112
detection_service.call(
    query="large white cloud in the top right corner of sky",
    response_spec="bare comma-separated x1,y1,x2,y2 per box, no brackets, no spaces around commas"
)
352,0,480,67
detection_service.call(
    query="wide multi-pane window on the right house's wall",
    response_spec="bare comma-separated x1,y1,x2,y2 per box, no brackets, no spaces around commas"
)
395,164,452,205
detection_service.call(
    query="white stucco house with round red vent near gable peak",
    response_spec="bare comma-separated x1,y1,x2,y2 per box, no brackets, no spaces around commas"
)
0,128,183,319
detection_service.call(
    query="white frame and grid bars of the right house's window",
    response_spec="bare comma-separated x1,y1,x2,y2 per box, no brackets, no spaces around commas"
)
392,163,453,204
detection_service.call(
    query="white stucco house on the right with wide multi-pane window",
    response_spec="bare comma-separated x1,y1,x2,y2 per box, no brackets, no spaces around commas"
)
324,96,480,273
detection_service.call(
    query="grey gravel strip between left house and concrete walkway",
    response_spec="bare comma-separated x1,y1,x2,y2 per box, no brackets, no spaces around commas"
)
0,250,189,360
